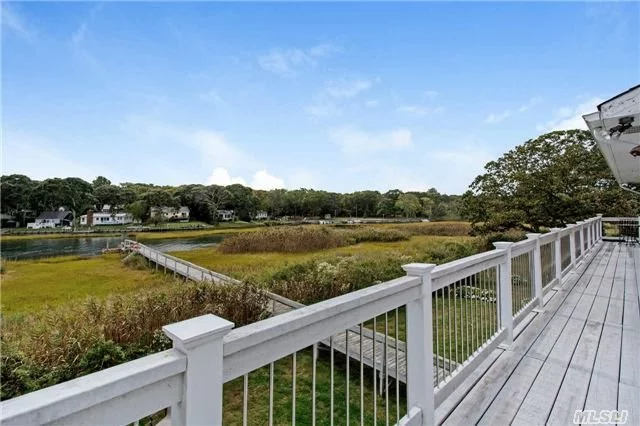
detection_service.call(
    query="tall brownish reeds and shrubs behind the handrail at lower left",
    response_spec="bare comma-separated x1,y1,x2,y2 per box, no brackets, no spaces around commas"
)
0,283,268,399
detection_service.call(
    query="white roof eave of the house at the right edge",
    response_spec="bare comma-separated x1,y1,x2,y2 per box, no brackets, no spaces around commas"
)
583,85,640,185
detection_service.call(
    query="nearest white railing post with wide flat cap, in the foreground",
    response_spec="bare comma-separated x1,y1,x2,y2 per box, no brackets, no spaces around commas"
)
162,314,233,426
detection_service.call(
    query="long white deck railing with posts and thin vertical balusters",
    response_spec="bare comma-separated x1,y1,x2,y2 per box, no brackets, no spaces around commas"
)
0,217,602,425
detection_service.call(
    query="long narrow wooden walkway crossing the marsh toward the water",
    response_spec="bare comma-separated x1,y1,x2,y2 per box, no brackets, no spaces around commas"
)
123,241,456,391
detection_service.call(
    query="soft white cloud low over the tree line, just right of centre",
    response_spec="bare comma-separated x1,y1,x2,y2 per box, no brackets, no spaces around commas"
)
329,126,413,155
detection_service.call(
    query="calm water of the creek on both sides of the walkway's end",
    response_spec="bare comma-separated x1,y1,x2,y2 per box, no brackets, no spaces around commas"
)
1,234,225,260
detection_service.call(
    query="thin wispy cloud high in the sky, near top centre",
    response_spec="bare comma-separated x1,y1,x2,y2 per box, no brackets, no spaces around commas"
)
258,43,341,77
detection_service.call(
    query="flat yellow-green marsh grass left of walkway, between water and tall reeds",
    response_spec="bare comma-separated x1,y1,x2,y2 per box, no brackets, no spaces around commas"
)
0,254,178,316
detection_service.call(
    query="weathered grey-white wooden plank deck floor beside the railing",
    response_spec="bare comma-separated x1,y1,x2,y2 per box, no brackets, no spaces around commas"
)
436,242,640,426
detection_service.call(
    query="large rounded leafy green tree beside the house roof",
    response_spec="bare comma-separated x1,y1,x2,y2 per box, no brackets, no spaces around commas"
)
462,130,638,232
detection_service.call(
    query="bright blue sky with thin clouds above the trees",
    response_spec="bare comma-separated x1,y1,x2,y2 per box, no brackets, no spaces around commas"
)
2,2,640,193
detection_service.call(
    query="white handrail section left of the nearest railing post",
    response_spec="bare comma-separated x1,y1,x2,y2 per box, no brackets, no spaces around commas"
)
0,349,187,425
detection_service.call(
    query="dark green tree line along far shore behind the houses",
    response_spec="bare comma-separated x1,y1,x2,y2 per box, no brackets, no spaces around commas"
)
0,174,460,223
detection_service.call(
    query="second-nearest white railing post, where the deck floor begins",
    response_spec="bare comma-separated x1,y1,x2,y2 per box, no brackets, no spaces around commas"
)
402,263,436,425
